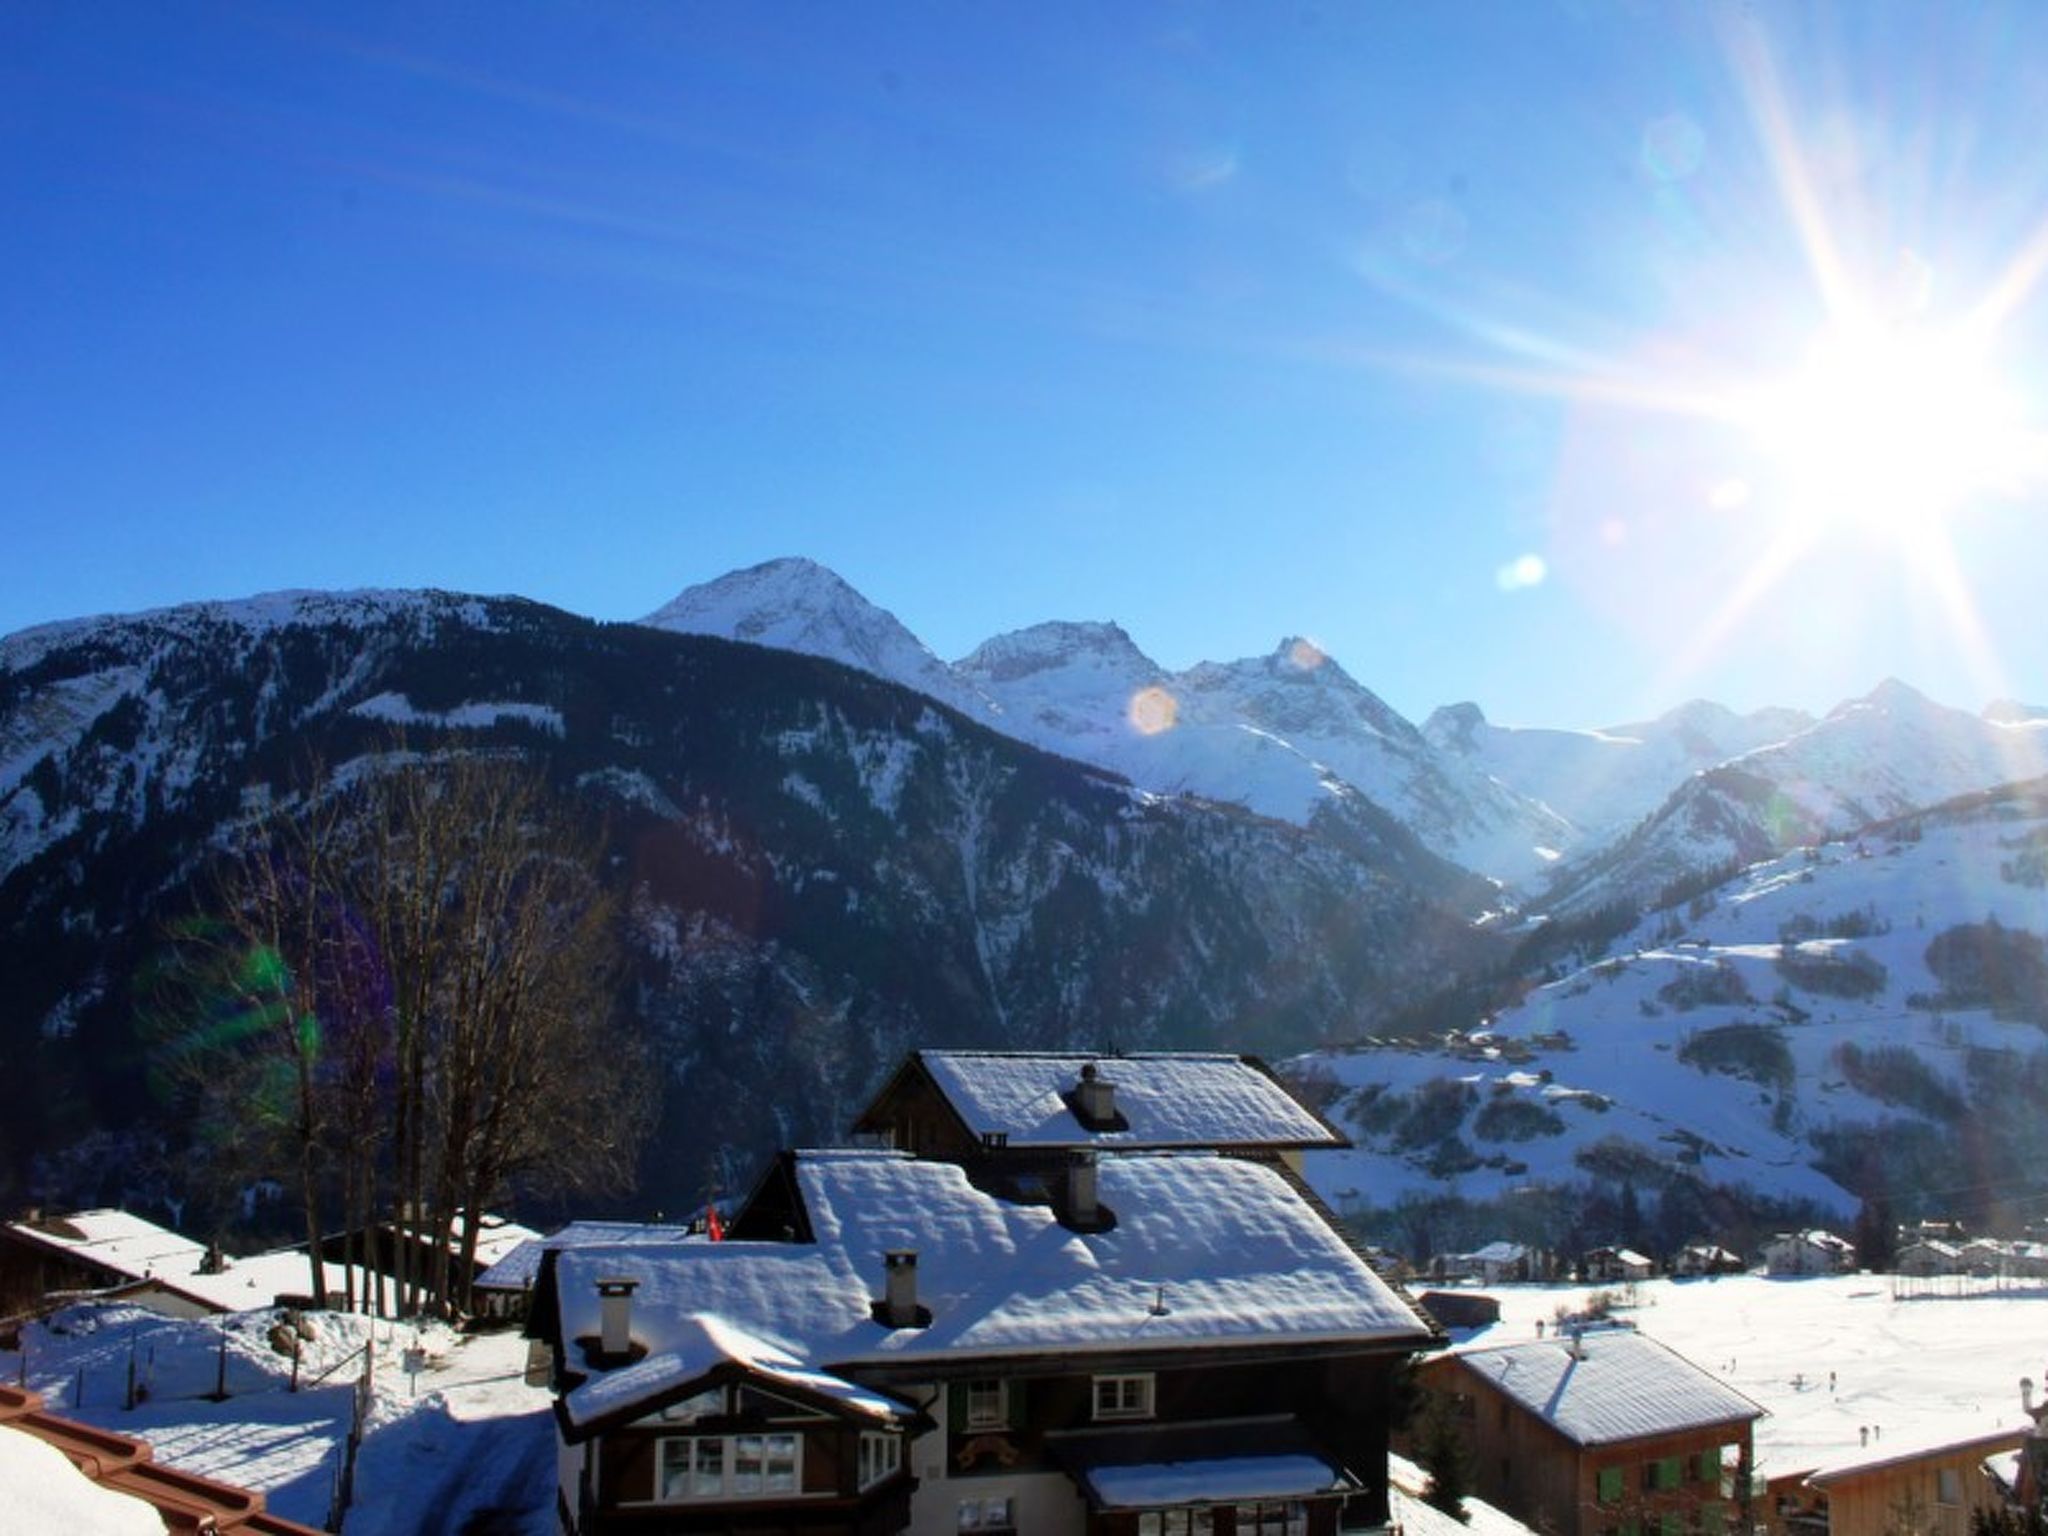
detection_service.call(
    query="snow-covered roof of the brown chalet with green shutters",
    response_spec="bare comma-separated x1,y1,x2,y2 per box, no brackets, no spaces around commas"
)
1458,1329,1763,1446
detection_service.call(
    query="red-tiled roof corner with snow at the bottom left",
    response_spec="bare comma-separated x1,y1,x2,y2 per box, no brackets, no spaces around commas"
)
0,1386,315,1536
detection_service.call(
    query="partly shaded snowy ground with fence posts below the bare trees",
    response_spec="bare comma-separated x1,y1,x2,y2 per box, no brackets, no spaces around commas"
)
0,1305,555,1536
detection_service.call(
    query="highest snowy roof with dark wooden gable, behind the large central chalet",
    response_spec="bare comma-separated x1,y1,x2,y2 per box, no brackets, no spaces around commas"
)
854,1051,1352,1174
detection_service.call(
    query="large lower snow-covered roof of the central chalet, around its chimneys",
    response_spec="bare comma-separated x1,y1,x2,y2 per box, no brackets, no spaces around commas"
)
555,1151,1430,1425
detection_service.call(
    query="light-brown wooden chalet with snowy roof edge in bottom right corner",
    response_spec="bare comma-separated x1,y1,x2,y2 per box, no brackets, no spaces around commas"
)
1806,1427,2025,1536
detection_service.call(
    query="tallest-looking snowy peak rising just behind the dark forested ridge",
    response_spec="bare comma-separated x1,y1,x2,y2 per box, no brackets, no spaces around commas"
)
641,555,993,717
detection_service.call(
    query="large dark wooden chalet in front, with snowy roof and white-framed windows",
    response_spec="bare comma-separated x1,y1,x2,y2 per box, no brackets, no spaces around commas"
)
530,1146,1436,1536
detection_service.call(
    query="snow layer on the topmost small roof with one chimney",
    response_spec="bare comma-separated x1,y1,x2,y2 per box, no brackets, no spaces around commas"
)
918,1051,1346,1147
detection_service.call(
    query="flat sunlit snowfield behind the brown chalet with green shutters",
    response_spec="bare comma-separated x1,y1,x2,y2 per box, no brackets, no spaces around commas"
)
1452,1274,2048,1477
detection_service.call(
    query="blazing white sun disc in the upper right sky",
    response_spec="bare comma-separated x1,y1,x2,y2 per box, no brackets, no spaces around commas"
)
1745,324,2023,541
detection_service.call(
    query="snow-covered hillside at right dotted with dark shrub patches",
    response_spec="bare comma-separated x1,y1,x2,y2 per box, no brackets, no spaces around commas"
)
1303,788,2048,1217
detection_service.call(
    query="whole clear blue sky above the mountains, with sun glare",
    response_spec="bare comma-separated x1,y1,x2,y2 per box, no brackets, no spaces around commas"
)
0,0,2048,725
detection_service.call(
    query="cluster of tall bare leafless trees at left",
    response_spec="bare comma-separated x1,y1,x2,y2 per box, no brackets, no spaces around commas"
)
143,752,651,1313
